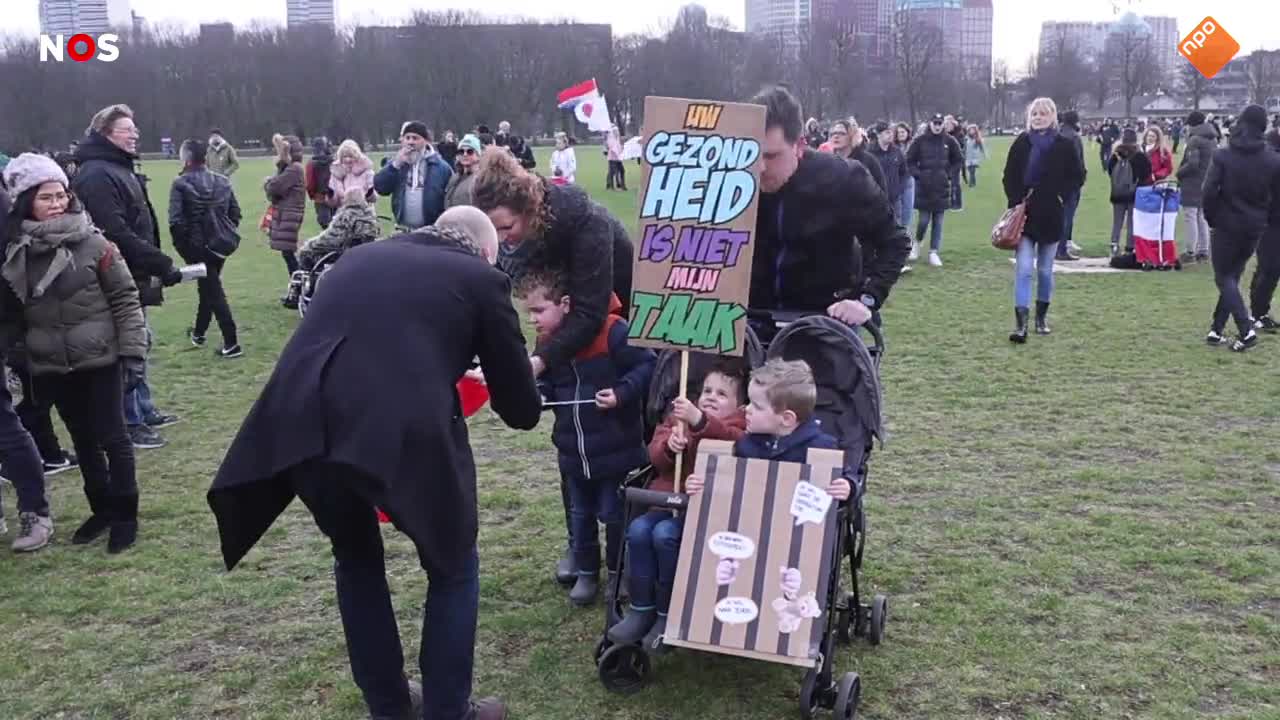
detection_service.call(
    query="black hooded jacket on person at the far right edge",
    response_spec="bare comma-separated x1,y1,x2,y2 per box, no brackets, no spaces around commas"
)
1203,123,1280,234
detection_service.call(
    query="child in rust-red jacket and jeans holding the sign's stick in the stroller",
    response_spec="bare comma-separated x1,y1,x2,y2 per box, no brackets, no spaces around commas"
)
609,361,746,650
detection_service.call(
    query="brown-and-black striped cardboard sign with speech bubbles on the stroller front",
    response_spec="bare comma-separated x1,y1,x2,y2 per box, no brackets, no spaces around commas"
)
663,441,844,667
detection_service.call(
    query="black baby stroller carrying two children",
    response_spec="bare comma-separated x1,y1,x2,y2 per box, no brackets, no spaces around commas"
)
595,311,888,720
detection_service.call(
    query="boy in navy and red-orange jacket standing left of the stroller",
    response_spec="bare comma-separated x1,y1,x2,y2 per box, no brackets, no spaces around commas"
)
516,273,657,607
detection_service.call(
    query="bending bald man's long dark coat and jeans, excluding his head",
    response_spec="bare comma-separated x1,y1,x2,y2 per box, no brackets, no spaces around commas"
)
209,223,541,720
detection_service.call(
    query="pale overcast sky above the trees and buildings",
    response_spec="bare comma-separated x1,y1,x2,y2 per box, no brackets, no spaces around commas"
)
0,0,1280,69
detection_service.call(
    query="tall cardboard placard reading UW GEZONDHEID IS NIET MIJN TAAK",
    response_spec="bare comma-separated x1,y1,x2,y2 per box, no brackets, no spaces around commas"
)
630,97,764,355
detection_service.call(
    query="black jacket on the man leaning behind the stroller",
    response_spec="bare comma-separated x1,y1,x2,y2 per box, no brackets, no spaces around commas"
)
750,151,911,311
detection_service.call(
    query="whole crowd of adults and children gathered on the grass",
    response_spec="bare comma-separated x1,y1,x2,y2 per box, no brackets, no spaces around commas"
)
0,79,1280,720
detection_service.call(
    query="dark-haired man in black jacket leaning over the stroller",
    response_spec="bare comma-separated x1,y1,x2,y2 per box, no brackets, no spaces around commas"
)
750,87,910,325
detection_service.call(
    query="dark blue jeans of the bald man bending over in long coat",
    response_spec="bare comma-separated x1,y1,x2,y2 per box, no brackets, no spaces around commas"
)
292,461,480,720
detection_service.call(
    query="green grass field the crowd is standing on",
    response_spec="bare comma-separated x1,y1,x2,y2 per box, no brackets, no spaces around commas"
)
0,141,1280,720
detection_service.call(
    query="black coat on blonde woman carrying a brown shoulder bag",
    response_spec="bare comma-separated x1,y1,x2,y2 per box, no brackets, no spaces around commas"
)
1004,132,1084,243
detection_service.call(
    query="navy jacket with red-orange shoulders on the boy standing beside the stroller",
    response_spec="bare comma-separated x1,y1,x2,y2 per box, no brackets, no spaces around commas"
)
541,311,657,479
